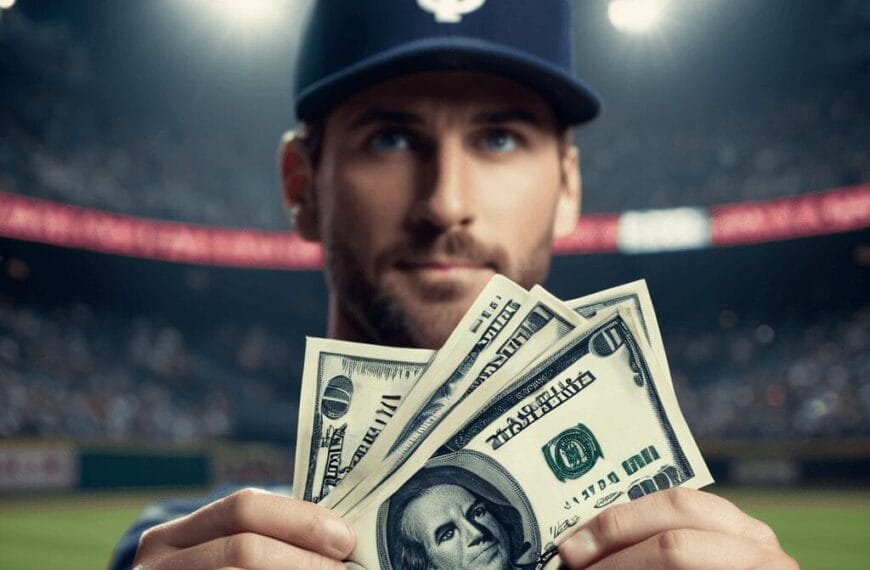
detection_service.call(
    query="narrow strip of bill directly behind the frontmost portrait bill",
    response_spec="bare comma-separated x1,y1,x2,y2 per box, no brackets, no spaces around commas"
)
334,287,586,514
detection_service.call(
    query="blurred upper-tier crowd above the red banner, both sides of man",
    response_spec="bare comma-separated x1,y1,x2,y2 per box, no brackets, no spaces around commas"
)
0,8,870,226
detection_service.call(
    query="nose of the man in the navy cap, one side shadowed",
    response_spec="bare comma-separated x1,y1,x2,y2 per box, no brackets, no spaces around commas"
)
414,137,474,231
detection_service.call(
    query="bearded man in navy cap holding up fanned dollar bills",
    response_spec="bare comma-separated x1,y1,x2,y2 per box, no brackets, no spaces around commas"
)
118,0,796,568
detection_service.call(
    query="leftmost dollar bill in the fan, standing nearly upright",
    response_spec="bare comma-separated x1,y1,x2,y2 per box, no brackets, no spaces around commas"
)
293,337,435,502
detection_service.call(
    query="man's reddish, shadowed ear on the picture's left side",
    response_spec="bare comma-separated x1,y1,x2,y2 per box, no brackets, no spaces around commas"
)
278,131,320,241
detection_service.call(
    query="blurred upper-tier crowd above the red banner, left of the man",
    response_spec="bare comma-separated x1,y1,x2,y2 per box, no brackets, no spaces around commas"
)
0,11,287,229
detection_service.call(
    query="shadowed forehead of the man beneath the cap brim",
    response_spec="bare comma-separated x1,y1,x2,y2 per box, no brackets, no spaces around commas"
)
329,72,555,126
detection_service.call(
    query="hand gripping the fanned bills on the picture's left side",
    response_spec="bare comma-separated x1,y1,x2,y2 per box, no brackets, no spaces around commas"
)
134,489,356,570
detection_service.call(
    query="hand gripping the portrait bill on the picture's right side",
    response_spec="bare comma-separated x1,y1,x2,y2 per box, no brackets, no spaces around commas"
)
559,488,798,570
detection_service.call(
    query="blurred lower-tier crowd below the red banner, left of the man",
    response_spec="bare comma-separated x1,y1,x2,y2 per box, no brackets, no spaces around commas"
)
0,303,295,442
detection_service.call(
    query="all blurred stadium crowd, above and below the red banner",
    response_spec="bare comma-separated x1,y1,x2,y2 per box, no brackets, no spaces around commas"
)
0,6,870,441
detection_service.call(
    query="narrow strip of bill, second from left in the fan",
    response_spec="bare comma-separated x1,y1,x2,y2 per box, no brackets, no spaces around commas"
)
321,275,528,508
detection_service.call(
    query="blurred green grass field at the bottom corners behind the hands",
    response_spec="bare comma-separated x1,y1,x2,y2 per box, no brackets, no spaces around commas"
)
0,489,870,570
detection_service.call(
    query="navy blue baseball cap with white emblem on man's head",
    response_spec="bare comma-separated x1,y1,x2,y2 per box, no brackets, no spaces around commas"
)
295,0,601,125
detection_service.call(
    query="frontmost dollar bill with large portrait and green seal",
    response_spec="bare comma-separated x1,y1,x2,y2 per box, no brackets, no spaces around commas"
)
347,309,712,569
